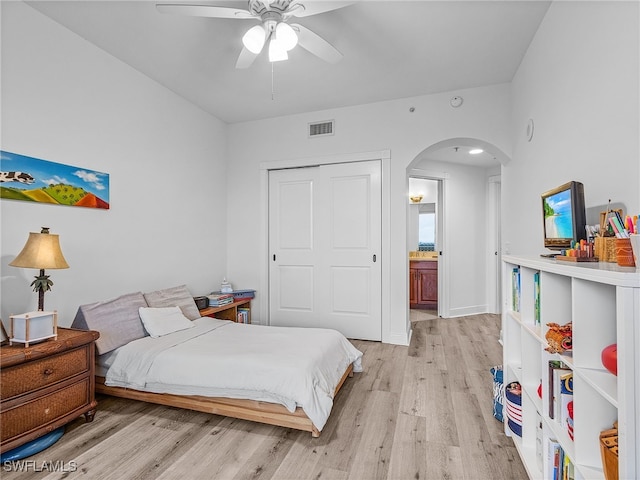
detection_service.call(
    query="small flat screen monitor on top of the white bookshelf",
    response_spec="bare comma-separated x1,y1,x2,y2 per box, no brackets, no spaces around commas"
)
542,181,586,250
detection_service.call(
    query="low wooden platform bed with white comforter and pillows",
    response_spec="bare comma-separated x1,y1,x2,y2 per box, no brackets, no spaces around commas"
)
74,286,362,437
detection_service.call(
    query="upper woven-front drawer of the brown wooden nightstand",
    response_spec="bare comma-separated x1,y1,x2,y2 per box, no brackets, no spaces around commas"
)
0,347,90,402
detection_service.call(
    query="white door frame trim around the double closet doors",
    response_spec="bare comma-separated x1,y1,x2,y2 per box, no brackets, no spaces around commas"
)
257,150,392,344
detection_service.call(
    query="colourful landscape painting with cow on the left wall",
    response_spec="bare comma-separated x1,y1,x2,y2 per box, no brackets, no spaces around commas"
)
0,150,109,209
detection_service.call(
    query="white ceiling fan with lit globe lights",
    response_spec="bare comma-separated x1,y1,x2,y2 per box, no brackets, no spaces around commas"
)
156,0,354,68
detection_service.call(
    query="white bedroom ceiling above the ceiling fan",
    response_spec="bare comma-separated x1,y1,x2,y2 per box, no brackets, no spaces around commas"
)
22,0,550,166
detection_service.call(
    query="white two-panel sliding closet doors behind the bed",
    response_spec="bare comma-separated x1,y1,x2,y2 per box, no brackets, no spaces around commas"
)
269,160,382,341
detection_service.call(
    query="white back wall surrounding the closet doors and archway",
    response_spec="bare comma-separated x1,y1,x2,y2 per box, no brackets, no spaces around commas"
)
228,85,511,343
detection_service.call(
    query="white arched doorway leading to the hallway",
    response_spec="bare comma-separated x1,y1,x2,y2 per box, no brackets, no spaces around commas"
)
407,138,510,317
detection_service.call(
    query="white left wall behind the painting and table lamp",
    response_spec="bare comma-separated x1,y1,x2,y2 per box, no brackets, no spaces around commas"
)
0,2,227,326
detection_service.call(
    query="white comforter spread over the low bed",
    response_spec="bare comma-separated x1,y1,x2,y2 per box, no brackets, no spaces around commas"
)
105,317,362,430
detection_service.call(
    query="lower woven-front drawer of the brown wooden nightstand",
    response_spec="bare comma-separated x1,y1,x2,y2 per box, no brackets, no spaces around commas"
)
0,378,91,442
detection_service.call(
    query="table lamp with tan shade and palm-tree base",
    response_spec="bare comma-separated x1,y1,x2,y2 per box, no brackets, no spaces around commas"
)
9,227,69,311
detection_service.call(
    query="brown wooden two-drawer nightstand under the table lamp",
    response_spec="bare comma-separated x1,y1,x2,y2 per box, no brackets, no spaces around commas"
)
0,328,100,452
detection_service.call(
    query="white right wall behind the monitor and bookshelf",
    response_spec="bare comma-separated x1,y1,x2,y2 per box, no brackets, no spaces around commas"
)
502,1,640,254
